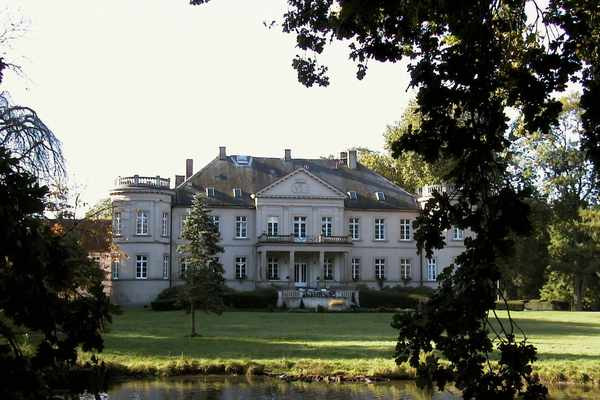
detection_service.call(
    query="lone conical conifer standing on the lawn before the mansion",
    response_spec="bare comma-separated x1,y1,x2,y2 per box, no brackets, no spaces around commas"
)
179,194,225,336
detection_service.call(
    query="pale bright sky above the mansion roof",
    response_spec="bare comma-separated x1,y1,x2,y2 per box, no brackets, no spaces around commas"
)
0,0,412,209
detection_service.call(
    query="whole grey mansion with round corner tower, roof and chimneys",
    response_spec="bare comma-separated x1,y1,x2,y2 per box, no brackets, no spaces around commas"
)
111,147,464,305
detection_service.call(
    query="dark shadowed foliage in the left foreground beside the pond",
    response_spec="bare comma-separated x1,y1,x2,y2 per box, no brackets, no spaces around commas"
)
0,147,111,399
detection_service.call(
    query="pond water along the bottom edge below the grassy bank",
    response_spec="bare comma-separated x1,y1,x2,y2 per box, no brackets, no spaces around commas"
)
99,376,600,400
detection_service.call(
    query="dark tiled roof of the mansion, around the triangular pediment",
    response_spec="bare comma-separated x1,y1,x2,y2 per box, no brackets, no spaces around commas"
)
175,156,418,210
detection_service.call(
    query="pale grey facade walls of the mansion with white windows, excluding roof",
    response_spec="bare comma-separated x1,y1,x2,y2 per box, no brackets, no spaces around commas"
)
111,152,464,304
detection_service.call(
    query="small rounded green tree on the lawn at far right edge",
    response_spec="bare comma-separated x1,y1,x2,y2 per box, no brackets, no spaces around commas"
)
548,209,600,311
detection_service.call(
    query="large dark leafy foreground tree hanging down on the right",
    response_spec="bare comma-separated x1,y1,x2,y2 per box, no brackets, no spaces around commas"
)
191,0,600,399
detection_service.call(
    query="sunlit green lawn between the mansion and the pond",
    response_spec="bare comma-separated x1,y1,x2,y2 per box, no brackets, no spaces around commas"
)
92,309,600,382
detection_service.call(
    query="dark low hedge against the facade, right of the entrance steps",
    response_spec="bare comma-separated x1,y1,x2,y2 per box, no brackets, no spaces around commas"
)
359,286,431,309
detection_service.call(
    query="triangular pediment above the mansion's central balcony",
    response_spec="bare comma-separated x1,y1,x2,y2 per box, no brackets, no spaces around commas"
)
256,168,346,199
